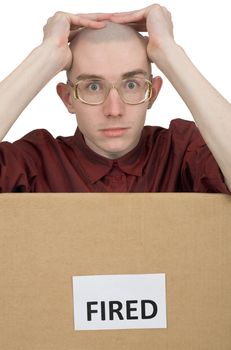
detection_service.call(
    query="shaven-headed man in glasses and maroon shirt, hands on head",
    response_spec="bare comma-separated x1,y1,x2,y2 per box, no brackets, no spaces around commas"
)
0,5,231,193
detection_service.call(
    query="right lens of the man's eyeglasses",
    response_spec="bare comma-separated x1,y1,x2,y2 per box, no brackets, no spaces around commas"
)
119,78,151,104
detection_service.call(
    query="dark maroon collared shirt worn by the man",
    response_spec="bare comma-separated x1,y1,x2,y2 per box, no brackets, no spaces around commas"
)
0,119,230,193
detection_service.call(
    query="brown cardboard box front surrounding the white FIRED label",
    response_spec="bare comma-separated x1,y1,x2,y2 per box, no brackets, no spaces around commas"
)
0,193,231,350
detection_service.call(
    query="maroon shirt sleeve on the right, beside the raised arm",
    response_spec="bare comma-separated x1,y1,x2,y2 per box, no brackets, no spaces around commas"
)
181,124,231,194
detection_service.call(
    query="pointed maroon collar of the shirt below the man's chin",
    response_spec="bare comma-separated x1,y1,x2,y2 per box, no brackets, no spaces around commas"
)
74,128,145,183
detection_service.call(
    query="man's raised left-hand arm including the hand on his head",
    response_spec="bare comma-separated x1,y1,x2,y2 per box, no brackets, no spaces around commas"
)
0,12,109,140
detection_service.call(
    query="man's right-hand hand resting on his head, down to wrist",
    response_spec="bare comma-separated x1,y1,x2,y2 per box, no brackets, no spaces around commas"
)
110,4,174,62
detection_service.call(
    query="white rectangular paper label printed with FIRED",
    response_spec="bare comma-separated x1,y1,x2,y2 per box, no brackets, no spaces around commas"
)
73,273,166,330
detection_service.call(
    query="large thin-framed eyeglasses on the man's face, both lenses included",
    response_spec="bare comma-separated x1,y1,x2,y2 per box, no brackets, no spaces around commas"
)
67,77,152,105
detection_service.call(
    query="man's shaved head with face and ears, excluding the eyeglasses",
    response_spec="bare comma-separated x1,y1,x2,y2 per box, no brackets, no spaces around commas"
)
57,22,162,158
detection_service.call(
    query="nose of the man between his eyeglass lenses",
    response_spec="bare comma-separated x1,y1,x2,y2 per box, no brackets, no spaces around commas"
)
103,88,124,118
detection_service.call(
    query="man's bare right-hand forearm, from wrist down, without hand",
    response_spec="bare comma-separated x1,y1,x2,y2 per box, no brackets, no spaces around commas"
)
155,43,231,190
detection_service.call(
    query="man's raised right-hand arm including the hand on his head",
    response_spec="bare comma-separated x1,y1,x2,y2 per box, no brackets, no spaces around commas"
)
112,5,231,191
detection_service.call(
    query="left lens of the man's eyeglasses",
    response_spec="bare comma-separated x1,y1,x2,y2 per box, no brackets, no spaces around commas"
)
77,80,107,104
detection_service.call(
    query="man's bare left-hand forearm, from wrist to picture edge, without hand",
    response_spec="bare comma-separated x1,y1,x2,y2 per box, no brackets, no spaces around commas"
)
0,42,62,140
